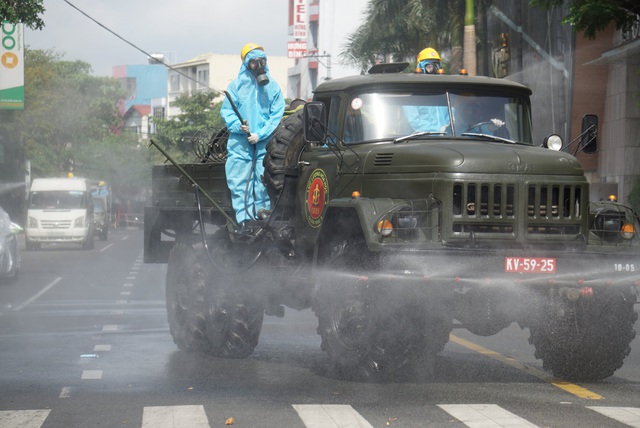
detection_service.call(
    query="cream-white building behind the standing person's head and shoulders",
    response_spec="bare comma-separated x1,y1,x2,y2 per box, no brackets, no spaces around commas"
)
166,52,293,118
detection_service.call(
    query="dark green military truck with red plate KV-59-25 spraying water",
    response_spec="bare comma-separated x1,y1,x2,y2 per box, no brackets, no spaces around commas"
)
144,64,640,380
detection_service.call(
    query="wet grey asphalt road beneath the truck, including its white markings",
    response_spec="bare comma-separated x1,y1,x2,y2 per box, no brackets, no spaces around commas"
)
0,229,640,428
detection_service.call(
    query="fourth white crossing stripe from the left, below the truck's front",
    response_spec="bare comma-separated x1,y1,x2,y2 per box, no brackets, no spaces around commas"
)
438,404,537,428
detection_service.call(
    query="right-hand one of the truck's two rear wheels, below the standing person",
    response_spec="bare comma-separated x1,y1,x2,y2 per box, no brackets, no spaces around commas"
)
205,230,264,358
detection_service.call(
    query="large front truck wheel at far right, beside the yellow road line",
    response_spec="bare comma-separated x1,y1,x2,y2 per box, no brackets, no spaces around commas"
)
529,290,638,381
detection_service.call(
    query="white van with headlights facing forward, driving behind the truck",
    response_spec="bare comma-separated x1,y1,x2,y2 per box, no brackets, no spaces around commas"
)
25,178,94,250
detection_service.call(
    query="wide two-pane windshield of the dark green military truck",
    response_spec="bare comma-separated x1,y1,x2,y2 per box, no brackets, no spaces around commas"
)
342,92,533,144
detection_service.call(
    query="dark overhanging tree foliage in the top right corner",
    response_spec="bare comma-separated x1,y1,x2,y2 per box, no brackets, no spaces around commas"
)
529,0,640,39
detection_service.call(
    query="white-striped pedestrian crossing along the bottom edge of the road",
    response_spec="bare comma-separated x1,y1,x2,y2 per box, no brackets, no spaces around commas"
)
0,404,640,428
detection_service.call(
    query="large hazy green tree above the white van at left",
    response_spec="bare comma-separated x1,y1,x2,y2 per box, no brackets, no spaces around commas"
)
0,49,124,176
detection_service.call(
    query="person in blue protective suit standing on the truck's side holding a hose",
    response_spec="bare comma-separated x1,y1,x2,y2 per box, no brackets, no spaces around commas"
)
220,43,285,231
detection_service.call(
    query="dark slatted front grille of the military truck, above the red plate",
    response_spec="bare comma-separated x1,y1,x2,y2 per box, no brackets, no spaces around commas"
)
452,182,583,235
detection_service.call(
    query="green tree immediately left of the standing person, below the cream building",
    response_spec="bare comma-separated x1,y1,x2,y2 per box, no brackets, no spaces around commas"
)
154,92,225,162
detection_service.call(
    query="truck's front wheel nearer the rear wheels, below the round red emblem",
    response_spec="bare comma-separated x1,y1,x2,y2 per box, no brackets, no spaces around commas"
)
313,237,418,381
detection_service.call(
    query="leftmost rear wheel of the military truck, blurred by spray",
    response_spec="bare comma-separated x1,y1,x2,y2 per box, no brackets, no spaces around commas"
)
166,241,213,351
